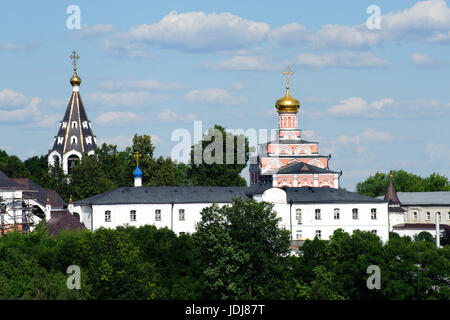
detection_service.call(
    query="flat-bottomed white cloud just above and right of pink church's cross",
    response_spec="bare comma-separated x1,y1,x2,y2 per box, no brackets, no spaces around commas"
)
294,51,387,68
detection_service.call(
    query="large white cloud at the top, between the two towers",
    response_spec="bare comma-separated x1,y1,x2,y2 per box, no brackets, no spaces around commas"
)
105,11,270,52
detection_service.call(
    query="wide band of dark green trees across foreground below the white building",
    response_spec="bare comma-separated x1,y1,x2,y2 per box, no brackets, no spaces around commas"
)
0,199,450,300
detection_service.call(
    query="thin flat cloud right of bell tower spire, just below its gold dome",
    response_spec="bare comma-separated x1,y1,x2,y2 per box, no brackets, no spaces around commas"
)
86,91,168,107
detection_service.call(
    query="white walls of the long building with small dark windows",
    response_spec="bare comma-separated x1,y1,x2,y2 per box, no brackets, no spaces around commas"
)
74,195,389,242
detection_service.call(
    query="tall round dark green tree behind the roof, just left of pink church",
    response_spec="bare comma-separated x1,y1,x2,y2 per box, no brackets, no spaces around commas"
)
188,125,249,186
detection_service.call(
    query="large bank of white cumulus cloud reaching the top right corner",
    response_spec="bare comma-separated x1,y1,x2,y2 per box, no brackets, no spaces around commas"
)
270,0,450,49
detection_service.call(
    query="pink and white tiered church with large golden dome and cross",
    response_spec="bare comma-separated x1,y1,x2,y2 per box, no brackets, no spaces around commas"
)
250,67,342,188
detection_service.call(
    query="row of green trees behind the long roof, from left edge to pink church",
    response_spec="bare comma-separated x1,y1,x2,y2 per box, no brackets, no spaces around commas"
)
0,125,249,201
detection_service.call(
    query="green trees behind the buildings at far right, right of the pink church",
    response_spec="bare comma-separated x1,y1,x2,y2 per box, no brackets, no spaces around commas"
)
356,170,450,197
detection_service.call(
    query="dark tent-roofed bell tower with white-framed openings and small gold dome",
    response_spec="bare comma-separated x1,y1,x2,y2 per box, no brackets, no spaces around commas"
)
48,51,97,174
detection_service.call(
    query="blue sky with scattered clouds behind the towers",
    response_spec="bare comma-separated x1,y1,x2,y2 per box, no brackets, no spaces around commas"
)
0,0,450,190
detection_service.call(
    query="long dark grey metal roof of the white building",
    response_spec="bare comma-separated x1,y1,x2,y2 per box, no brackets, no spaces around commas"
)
75,186,386,205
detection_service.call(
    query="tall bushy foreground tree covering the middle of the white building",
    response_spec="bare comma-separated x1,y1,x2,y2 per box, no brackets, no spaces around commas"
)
194,198,290,299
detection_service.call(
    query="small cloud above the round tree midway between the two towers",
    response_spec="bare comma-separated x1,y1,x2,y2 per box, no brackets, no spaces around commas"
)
184,88,247,106
